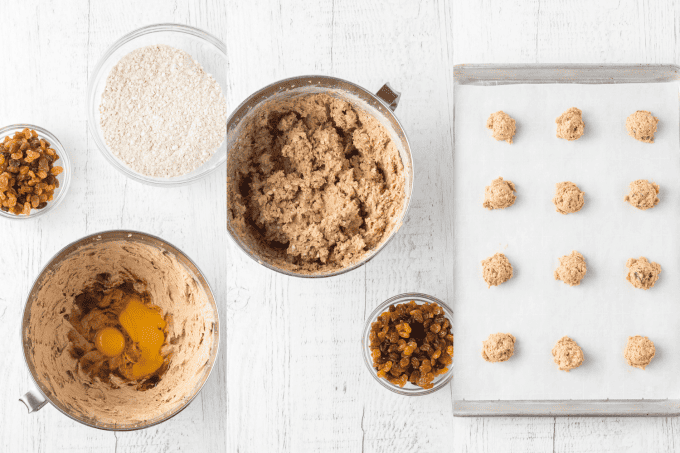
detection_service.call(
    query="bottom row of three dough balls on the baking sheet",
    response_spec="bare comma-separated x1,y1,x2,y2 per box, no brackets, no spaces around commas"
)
482,333,656,371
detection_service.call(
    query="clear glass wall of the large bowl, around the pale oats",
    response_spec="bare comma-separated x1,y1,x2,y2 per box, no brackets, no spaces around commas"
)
87,24,227,187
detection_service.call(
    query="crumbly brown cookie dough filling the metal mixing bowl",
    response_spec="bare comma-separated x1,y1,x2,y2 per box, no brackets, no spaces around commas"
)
227,94,405,274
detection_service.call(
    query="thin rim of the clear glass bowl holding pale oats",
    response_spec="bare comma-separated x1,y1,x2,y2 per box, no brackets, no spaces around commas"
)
85,23,227,187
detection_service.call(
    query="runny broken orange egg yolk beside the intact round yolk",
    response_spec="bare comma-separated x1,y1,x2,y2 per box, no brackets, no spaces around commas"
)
118,297,165,379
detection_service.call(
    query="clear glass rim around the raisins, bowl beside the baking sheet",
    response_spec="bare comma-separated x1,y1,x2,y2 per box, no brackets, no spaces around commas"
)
361,293,453,396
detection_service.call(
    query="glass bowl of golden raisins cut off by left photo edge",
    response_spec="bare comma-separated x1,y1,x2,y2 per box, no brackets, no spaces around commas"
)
0,124,71,220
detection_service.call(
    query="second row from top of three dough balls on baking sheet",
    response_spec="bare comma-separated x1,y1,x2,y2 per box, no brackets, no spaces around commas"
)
482,177,659,214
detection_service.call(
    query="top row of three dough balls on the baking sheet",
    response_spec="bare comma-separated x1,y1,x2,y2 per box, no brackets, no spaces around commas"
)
486,107,659,144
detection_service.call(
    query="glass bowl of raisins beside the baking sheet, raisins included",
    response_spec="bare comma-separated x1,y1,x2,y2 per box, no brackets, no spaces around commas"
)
361,293,453,396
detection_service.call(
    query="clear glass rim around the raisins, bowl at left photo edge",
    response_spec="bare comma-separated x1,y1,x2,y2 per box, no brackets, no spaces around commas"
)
0,124,72,220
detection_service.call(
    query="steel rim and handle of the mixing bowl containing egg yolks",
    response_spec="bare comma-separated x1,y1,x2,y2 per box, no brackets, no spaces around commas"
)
19,230,220,431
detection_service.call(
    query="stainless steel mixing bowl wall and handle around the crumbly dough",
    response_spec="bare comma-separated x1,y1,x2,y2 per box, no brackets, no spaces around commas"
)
227,75,414,278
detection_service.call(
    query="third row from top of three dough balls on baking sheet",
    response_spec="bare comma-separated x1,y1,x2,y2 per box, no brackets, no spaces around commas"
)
482,250,661,290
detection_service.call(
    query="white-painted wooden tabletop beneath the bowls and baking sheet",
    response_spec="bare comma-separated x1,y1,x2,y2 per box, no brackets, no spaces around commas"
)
0,0,680,453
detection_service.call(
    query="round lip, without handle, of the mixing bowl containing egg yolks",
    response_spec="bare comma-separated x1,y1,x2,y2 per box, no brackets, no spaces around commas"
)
19,229,221,431
